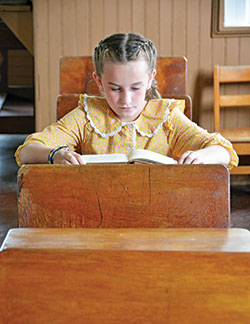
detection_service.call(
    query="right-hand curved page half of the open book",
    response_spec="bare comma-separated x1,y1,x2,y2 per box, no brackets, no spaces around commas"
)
128,149,177,164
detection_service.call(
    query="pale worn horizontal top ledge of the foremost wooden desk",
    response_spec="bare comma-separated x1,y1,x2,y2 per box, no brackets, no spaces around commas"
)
0,228,250,252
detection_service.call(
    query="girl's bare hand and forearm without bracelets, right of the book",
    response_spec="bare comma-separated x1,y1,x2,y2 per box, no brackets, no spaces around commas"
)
179,145,231,165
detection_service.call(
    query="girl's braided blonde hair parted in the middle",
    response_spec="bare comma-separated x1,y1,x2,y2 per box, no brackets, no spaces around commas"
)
93,33,161,101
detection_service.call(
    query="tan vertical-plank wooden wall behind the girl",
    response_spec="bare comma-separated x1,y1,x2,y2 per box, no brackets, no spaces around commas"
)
33,0,250,131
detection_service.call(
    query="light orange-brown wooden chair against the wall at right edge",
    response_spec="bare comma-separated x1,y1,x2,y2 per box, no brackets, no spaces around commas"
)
214,65,250,174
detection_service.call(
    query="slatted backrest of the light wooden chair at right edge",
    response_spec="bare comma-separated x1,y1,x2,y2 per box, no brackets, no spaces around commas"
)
214,65,250,131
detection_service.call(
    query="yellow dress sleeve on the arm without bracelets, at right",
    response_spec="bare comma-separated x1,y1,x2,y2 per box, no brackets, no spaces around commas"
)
166,108,239,169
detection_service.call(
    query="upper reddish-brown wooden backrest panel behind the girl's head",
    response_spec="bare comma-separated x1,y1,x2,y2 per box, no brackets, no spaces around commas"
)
60,56,187,97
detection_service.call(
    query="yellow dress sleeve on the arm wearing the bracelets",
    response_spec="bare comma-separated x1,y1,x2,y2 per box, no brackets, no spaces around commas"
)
15,107,87,166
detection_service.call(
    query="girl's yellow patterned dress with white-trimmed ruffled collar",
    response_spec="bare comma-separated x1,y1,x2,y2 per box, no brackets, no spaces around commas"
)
15,95,238,169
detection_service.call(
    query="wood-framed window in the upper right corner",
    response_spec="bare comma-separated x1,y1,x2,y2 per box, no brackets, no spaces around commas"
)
212,0,250,37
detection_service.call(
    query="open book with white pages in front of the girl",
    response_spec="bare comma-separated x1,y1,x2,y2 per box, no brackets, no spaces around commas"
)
83,149,177,164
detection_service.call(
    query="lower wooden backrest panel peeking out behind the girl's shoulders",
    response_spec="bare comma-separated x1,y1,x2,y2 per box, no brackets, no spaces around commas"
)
57,94,192,119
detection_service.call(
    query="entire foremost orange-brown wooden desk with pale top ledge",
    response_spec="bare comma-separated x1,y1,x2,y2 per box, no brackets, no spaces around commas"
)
0,229,250,324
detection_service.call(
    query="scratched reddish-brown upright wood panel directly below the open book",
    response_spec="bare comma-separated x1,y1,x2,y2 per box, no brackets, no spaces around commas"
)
18,164,230,228
